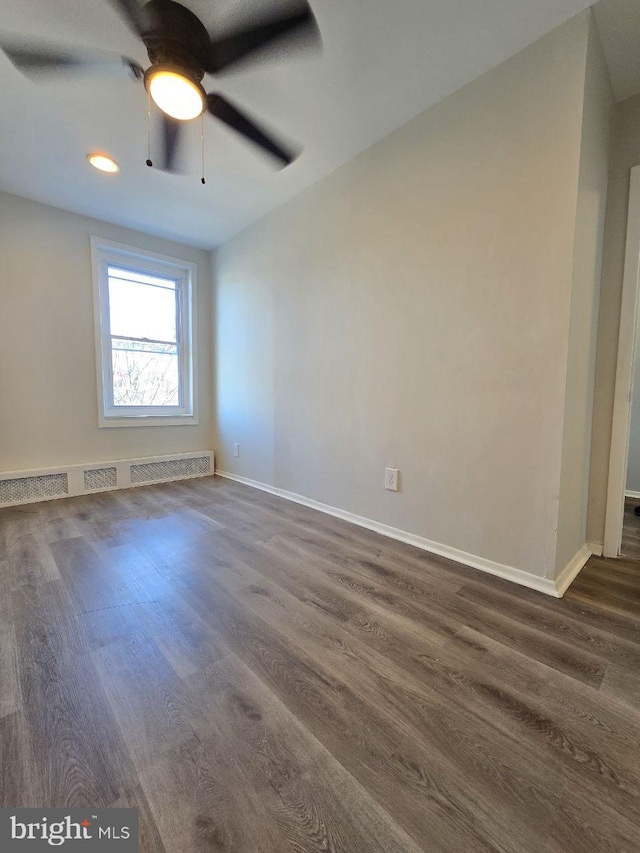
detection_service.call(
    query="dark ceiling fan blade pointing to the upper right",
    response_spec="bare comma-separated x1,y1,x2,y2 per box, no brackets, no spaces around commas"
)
204,0,321,74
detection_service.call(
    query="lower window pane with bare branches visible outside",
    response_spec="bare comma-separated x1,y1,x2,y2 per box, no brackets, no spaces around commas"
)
112,340,180,406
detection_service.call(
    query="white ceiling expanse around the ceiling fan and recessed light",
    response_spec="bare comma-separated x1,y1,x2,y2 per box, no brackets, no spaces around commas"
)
0,0,600,248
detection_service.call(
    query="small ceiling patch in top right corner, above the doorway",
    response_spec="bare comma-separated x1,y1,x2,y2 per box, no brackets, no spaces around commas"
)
594,0,640,101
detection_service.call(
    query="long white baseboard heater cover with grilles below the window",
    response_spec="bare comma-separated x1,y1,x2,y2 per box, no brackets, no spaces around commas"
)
0,450,214,507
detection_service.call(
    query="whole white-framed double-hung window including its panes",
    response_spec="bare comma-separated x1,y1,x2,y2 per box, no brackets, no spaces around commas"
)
91,237,196,427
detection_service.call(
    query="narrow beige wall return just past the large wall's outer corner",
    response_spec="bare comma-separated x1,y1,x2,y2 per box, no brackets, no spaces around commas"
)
556,15,614,573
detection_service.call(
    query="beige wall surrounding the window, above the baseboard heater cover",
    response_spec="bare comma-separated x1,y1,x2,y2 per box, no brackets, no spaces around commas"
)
0,193,212,471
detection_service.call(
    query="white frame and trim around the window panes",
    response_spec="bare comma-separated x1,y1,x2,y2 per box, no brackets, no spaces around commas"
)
91,237,198,428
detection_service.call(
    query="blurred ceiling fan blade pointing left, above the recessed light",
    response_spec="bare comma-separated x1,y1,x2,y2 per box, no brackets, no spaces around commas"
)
0,44,144,79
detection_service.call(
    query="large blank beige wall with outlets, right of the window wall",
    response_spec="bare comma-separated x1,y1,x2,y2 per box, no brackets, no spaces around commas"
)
214,13,594,577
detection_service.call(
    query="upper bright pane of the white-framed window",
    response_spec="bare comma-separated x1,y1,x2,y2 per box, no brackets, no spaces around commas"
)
109,268,176,341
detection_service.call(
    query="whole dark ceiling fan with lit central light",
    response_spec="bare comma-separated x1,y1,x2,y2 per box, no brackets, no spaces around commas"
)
0,0,320,175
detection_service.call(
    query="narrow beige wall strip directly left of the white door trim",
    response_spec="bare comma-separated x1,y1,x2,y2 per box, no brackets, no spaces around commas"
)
587,95,640,544
